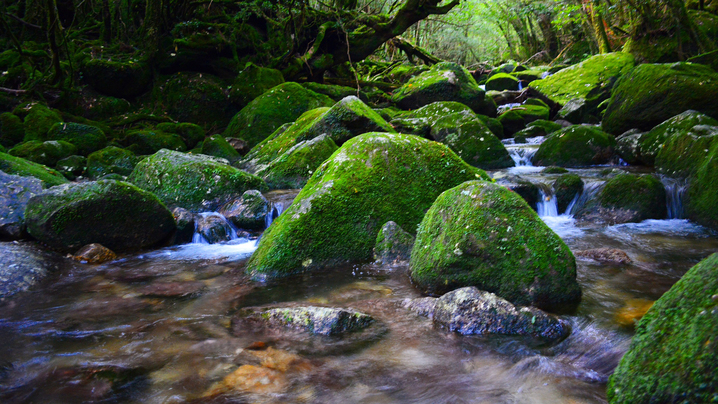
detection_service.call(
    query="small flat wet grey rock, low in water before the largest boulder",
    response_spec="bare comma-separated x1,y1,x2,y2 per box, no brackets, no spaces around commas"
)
258,306,374,335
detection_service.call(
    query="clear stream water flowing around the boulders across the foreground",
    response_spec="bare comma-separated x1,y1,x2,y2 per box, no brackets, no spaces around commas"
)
0,144,718,404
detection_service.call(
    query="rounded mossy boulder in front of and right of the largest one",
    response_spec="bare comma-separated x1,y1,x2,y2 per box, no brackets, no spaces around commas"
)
410,181,581,310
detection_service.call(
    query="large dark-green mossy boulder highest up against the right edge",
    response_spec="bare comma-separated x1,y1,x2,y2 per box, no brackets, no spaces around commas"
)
602,63,718,135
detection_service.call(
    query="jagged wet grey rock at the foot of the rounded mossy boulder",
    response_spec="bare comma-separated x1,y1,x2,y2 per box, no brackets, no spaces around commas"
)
405,287,571,342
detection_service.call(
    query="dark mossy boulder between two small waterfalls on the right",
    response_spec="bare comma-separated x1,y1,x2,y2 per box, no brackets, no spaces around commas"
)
576,173,667,223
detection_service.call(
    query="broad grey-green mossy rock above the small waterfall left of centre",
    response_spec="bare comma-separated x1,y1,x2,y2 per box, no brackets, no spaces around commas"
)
128,149,267,212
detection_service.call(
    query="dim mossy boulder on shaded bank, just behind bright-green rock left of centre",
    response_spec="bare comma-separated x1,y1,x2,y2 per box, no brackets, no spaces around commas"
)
229,63,284,109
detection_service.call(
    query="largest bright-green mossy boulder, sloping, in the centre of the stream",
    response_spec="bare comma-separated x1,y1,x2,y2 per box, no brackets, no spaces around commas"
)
247,133,488,278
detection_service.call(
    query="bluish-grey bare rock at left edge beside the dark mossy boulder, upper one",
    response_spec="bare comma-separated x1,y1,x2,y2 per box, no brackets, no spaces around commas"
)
0,171,42,240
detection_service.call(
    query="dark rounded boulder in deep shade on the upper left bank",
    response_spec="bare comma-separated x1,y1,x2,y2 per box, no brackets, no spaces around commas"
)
82,59,152,98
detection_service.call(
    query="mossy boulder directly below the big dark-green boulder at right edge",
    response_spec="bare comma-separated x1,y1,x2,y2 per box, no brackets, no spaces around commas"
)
638,110,718,166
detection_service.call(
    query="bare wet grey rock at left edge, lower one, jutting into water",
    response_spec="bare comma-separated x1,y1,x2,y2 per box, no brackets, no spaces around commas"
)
0,242,63,300
